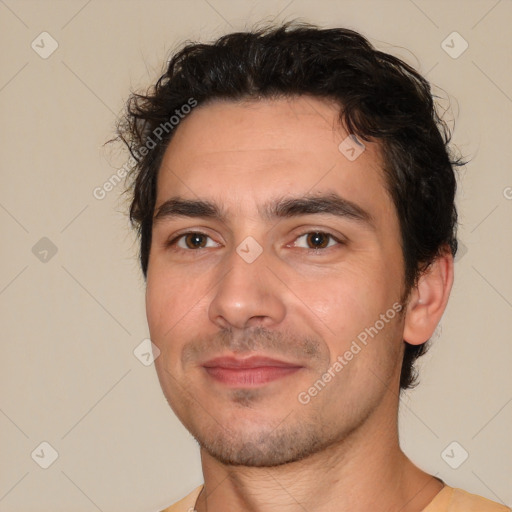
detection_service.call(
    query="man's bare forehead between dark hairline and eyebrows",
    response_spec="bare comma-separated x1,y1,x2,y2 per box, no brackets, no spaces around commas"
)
156,96,390,220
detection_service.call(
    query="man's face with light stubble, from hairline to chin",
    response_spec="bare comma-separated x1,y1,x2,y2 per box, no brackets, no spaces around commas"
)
146,97,410,466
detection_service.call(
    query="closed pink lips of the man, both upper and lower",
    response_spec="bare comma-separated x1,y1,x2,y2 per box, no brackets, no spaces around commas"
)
202,356,303,388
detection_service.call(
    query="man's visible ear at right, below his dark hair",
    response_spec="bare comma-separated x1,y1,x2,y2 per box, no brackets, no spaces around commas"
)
404,248,453,345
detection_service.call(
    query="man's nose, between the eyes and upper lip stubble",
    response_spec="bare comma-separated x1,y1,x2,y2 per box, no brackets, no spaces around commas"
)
208,245,286,329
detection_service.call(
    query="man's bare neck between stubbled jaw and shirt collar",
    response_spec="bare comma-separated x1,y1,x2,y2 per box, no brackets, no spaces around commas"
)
196,398,443,512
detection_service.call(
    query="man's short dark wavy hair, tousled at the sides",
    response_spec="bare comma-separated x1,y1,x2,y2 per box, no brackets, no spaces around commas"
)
118,22,464,389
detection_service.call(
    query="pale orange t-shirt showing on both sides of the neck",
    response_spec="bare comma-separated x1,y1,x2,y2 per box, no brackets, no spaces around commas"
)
161,485,511,512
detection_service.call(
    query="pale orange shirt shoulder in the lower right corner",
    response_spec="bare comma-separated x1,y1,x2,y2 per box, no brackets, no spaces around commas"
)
423,486,511,512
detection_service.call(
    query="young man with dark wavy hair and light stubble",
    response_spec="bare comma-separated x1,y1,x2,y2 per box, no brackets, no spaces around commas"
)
120,24,509,512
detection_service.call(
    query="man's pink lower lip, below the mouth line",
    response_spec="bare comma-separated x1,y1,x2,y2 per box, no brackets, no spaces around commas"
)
205,366,300,388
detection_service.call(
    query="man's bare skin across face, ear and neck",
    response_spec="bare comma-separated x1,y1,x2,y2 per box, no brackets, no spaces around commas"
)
146,96,453,512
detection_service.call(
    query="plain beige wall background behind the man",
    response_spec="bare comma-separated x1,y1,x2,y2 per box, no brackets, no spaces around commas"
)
0,0,512,512
